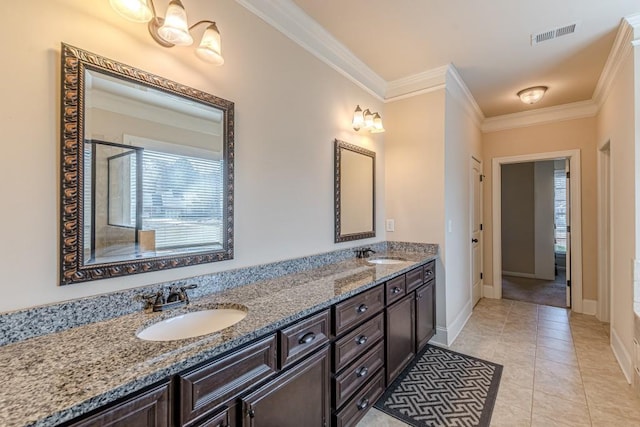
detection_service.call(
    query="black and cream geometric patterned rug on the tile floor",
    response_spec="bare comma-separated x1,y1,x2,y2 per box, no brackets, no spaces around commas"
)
374,345,502,427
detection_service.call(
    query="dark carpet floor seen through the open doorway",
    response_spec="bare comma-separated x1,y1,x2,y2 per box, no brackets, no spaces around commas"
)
502,270,567,308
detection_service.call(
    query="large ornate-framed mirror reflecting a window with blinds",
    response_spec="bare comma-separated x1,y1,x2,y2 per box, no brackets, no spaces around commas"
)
60,43,234,285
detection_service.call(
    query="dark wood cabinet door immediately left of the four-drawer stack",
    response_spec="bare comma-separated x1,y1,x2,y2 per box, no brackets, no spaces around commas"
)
242,347,331,427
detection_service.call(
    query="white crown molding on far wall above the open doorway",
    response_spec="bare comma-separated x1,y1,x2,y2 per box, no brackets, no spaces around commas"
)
481,100,599,133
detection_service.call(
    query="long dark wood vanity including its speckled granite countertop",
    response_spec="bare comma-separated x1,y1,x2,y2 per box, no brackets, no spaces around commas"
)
0,247,437,426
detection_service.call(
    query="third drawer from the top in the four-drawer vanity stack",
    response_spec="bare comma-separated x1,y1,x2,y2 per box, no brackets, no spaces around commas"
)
335,341,384,408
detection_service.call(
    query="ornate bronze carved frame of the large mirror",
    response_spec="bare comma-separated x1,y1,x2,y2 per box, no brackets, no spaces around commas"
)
60,43,234,285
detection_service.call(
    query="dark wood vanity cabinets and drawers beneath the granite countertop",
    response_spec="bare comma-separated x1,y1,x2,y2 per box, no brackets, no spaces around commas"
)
58,260,435,427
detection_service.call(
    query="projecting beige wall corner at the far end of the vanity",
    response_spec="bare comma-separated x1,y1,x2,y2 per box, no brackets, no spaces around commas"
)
385,81,481,344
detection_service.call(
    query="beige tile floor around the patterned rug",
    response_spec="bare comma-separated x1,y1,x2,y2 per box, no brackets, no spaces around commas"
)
357,299,640,427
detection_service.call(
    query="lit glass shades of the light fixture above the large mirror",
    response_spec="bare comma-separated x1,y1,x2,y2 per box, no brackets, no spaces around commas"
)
109,0,224,65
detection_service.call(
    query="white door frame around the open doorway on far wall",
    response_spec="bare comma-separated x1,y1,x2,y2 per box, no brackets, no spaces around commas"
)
485,150,582,313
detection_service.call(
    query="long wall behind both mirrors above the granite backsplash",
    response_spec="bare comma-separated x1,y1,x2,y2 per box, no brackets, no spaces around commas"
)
0,0,385,312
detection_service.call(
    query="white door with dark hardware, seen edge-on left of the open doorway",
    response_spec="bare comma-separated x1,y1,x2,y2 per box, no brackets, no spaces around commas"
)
471,157,482,306
